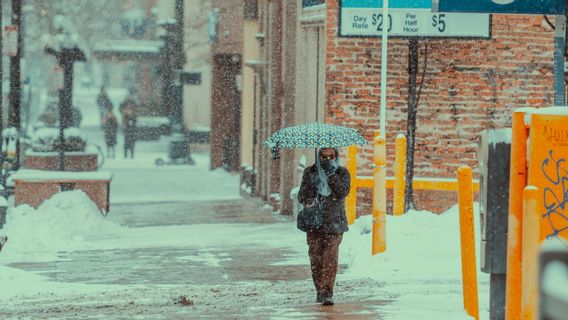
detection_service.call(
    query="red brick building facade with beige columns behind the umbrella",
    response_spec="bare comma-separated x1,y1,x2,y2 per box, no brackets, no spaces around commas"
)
241,0,554,214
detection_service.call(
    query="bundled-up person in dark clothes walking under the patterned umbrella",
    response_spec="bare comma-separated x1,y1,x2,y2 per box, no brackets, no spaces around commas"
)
298,148,351,305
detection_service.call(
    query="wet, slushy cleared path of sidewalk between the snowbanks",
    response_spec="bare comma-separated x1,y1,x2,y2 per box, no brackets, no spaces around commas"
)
0,199,388,319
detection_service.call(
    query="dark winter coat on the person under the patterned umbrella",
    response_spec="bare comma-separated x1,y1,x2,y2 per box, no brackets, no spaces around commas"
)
298,165,351,233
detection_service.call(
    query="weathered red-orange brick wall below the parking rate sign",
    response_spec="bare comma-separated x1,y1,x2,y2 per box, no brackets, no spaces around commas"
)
326,0,554,212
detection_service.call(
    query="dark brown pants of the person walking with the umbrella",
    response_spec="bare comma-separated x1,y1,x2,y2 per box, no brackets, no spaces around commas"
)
307,231,343,296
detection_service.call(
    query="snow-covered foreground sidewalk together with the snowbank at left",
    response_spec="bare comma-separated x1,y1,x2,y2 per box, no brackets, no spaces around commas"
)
0,191,389,319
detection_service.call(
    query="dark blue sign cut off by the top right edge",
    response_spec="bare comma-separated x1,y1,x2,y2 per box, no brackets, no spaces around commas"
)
432,0,566,15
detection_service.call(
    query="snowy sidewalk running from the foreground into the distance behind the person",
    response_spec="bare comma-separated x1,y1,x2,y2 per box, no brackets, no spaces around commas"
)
0,132,391,319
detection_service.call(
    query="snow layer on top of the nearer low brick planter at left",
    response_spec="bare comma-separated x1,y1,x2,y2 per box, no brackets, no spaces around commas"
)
12,169,112,181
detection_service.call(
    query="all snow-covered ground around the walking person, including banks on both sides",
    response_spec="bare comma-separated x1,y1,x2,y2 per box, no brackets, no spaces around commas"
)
0,143,489,319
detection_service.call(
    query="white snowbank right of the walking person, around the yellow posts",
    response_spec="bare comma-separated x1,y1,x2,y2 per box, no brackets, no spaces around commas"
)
338,204,489,320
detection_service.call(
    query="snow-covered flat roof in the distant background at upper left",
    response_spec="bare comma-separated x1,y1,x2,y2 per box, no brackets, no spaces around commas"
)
93,39,163,60
